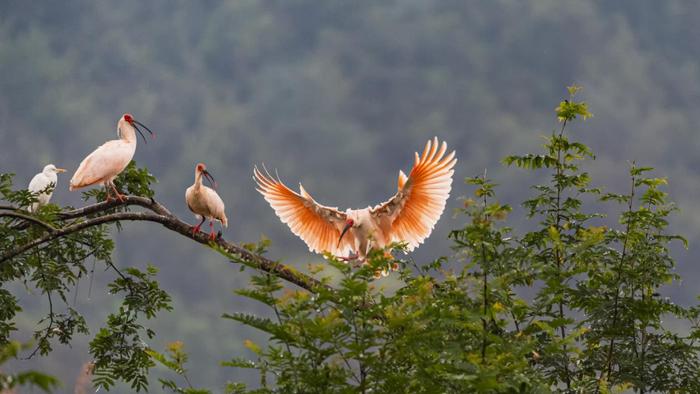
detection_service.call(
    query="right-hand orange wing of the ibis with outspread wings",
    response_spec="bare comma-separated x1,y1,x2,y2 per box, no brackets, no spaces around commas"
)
370,137,457,250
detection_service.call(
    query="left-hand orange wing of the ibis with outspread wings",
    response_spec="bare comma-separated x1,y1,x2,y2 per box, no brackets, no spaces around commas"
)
253,167,351,256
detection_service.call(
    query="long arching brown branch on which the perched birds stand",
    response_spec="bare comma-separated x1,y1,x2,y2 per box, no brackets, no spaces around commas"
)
0,196,327,292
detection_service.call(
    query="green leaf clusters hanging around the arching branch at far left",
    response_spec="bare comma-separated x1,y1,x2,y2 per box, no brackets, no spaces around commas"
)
0,162,171,391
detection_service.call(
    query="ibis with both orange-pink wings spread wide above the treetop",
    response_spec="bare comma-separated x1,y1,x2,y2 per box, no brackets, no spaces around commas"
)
253,138,457,260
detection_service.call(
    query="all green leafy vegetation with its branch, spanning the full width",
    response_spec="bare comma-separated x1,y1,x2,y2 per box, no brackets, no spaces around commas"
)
0,86,700,394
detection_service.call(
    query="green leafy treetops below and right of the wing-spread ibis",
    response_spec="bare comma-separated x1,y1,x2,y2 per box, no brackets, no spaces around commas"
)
215,86,700,393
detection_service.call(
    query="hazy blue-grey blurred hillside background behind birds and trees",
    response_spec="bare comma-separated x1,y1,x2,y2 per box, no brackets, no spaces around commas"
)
0,0,700,392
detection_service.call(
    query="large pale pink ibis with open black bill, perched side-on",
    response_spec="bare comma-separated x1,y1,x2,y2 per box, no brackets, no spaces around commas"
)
69,114,154,202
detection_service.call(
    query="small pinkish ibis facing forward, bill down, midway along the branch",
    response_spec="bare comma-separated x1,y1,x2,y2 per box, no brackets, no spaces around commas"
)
185,163,228,241
